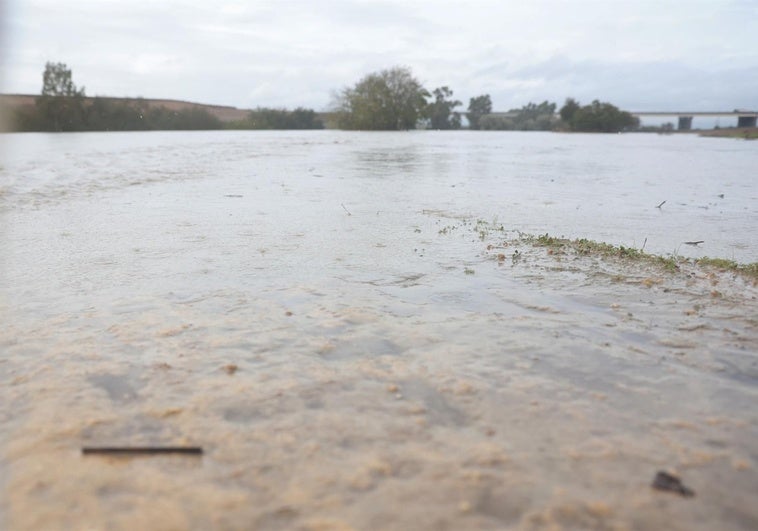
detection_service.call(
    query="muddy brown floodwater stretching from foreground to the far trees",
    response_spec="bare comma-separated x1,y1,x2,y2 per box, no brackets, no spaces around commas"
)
0,131,758,530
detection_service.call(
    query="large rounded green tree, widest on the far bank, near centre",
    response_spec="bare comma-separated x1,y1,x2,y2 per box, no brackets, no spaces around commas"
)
335,66,429,131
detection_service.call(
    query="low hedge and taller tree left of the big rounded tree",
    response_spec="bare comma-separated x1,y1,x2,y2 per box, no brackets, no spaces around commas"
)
11,63,324,132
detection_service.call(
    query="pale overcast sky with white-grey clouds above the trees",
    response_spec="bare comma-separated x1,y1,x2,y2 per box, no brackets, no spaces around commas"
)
0,0,758,111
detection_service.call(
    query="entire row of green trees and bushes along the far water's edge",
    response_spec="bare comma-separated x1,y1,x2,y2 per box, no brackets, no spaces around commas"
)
12,63,639,132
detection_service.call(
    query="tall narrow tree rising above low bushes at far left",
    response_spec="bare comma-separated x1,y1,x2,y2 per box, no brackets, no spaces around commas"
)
35,62,86,131
